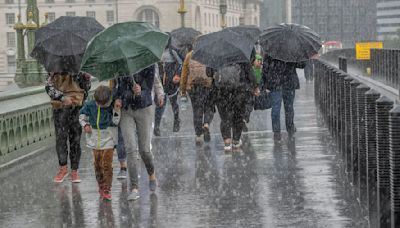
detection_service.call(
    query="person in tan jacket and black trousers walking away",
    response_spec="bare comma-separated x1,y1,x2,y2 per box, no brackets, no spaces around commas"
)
180,46,214,144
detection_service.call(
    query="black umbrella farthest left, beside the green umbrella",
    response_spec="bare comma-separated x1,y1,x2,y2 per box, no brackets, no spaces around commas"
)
31,16,104,73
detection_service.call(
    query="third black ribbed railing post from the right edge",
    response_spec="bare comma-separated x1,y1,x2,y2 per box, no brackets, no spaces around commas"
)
364,89,380,228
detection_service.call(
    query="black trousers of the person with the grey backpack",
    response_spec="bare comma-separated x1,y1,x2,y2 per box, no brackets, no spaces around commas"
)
216,88,251,141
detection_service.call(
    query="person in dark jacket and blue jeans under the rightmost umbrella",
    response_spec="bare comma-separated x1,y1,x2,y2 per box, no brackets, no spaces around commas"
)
263,55,305,141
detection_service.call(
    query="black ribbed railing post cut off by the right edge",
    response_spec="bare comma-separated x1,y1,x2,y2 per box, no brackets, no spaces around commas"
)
389,105,400,228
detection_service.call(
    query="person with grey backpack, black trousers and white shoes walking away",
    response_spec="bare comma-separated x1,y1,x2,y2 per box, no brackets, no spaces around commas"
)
207,60,260,151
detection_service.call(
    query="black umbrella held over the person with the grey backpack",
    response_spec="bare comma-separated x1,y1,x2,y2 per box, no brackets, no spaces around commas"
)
192,29,255,69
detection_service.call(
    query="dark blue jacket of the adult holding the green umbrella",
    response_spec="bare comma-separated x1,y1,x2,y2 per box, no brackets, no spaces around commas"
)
113,65,155,110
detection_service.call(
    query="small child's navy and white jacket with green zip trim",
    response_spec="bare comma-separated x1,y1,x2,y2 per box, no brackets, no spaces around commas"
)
79,100,121,150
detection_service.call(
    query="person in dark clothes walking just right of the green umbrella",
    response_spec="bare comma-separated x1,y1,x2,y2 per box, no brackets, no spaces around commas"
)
153,38,182,136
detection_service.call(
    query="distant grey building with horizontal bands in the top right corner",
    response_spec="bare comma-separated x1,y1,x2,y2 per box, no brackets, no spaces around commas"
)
376,1,400,40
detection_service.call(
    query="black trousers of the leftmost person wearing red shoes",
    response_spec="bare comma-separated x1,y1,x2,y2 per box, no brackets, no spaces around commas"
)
53,107,82,170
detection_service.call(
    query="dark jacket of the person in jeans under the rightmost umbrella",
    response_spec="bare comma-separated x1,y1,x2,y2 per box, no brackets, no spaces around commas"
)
262,55,305,91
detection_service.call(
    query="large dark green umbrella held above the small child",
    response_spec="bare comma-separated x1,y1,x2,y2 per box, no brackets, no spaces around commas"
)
81,22,169,81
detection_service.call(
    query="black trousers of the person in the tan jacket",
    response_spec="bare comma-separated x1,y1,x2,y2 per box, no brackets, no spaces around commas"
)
189,85,214,136
